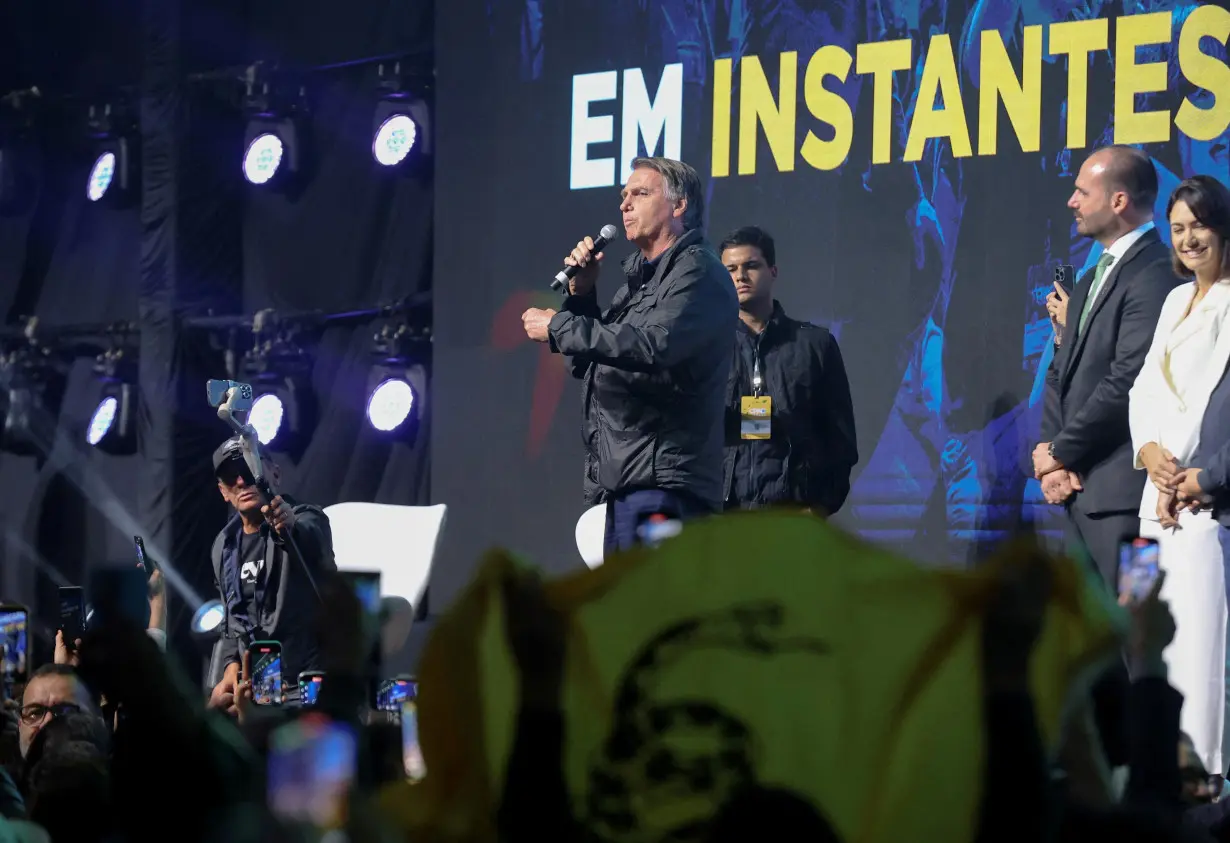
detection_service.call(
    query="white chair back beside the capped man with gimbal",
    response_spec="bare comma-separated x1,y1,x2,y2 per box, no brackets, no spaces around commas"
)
325,503,448,608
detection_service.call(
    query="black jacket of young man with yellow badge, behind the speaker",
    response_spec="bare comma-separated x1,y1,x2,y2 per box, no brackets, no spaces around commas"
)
724,302,859,514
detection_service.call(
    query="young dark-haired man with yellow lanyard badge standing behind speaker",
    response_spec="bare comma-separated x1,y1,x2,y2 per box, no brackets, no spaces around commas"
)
721,226,859,516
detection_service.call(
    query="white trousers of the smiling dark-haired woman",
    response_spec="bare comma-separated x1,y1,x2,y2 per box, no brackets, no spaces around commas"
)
1140,512,1230,774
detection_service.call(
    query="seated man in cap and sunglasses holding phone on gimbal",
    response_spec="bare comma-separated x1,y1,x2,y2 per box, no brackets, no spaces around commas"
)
209,436,337,711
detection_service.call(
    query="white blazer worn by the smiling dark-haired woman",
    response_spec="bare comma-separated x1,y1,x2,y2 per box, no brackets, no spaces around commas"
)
1128,278,1230,521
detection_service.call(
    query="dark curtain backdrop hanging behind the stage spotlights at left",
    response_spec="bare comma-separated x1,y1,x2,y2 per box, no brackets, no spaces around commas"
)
0,0,433,663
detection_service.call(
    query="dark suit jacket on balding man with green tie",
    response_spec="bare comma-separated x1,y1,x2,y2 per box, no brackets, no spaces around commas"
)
1042,230,1181,513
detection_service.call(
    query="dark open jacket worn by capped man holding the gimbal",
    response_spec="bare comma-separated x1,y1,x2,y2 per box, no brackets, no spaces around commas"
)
210,495,337,685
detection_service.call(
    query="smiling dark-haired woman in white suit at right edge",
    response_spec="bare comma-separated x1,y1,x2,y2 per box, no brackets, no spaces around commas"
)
1128,176,1230,770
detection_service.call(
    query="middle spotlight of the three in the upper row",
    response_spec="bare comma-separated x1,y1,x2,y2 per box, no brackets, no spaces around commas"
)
244,65,306,190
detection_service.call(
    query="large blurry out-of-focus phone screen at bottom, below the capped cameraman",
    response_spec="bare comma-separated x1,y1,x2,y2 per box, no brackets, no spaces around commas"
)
268,714,357,831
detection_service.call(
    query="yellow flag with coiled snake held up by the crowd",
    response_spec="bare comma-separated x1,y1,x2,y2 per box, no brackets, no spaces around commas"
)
387,512,1123,843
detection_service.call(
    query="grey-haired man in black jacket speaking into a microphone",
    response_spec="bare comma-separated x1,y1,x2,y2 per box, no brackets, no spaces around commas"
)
522,158,739,553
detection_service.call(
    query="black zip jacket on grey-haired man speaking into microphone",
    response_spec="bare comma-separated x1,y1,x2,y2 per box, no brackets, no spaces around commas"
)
550,230,739,511
